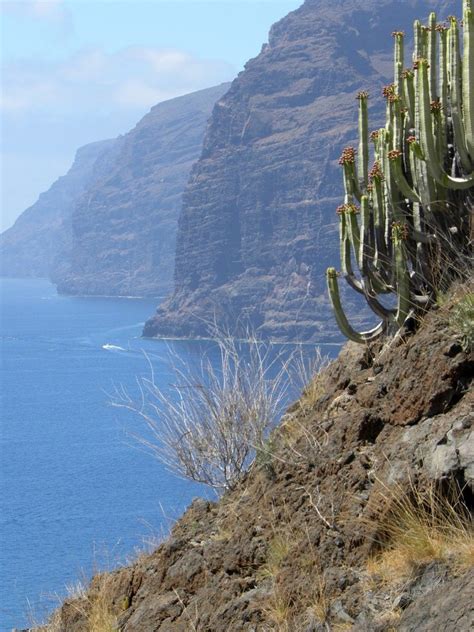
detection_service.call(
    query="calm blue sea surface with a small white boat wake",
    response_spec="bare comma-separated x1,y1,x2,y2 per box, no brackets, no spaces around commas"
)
0,279,337,632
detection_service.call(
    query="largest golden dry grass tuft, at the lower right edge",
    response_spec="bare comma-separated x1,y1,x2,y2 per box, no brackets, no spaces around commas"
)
367,478,474,584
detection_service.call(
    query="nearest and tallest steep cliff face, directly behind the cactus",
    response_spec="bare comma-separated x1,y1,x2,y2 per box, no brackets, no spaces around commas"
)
145,0,449,340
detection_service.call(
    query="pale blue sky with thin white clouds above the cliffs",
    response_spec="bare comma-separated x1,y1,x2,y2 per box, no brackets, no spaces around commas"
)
0,0,303,232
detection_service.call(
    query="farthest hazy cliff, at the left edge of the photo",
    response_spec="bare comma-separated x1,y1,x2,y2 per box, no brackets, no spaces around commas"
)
0,139,120,277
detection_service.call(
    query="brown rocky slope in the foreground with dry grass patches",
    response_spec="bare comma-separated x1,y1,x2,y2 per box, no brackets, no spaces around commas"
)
38,290,474,632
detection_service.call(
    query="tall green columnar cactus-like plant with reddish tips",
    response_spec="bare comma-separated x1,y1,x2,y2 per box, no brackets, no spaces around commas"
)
327,0,474,343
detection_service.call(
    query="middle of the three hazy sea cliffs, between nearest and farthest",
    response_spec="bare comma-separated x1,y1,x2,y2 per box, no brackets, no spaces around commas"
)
57,84,228,296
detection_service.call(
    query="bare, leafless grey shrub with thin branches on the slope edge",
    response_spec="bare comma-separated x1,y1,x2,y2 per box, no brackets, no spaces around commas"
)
111,332,326,491
